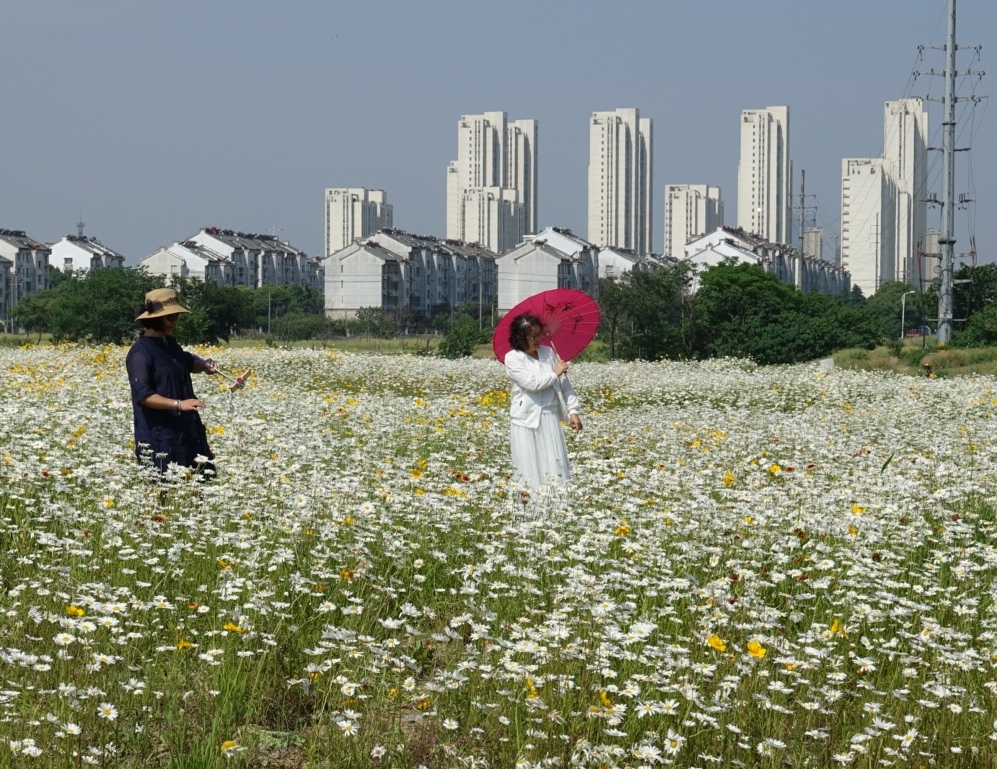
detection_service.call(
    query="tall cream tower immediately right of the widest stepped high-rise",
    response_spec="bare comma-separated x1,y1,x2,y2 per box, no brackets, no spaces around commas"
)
588,109,654,254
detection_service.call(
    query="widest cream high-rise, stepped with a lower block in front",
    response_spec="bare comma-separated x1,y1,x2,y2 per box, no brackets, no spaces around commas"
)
447,112,537,253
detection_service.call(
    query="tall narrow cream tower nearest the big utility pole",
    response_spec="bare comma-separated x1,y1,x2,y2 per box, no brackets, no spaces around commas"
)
883,99,929,286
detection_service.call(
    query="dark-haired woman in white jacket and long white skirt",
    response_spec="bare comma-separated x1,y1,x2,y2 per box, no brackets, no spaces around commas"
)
504,313,582,489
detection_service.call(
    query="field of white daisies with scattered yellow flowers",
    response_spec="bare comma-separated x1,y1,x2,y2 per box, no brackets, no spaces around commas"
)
0,346,997,769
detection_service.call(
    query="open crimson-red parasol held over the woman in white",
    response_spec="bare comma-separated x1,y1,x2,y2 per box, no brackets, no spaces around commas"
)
492,288,599,363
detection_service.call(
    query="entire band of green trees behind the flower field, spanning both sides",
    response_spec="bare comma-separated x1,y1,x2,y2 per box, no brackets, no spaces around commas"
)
14,262,997,364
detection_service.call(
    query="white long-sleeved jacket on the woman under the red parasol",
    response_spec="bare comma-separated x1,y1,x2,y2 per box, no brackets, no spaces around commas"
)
505,347,581,429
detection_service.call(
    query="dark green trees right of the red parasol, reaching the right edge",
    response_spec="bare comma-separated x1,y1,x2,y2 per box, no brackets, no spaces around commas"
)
599,262,997,364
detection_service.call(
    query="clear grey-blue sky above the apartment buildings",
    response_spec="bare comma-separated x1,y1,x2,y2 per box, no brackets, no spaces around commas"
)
0,0,997,265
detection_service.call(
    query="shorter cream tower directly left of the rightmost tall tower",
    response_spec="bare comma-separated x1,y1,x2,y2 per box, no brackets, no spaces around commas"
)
841,158,897,296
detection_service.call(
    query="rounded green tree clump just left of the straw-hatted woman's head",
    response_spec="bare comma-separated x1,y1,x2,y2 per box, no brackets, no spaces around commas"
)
44,268,161,344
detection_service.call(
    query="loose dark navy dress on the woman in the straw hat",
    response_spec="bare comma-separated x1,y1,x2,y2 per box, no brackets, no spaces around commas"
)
125,336,214,470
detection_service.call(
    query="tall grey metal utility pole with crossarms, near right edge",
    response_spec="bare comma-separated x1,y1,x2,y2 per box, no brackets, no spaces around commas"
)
915,0,983,344
